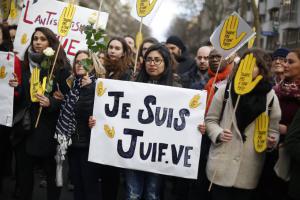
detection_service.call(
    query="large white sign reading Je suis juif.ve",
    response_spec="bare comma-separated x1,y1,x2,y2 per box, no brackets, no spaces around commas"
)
89,79,206,179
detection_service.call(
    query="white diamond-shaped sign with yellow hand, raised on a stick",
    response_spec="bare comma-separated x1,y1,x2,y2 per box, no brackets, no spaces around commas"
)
210,12,256,59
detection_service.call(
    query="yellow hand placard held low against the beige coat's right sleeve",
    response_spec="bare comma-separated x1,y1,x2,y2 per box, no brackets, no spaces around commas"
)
253,112,269,153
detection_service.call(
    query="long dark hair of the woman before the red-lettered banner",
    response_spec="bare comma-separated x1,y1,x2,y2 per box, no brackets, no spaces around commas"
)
24,27,71,70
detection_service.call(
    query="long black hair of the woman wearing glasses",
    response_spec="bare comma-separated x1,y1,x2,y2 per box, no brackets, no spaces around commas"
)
136,44,173,86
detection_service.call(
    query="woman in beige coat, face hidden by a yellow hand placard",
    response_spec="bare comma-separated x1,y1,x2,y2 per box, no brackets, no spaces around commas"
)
205,49,281,200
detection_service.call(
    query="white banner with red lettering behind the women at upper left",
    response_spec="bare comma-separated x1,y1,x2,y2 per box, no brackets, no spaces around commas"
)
14,0,108,60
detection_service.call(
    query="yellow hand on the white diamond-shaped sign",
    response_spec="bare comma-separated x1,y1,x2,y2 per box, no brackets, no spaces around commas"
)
220,15,247,50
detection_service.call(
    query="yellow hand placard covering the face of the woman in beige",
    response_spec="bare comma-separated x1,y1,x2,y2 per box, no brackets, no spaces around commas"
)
234,53,263,95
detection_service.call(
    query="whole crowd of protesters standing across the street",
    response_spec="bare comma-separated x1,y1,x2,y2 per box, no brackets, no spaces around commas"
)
0,17,300,200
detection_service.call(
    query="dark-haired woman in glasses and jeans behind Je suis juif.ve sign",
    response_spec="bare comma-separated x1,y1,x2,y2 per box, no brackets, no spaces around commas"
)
125,44,180,200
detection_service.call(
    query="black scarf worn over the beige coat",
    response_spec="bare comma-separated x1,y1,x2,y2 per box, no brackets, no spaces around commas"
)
230,81,272,142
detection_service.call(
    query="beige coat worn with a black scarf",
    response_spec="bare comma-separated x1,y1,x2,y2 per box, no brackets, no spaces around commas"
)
205,86,281,189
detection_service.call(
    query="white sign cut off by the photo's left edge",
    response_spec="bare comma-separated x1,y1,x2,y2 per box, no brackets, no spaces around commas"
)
0,51,15,127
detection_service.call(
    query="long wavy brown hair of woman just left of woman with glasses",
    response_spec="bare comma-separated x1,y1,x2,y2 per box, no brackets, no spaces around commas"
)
104,37,132,79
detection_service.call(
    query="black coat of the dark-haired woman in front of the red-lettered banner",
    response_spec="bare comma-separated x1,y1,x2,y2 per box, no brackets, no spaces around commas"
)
14,64,70,157
